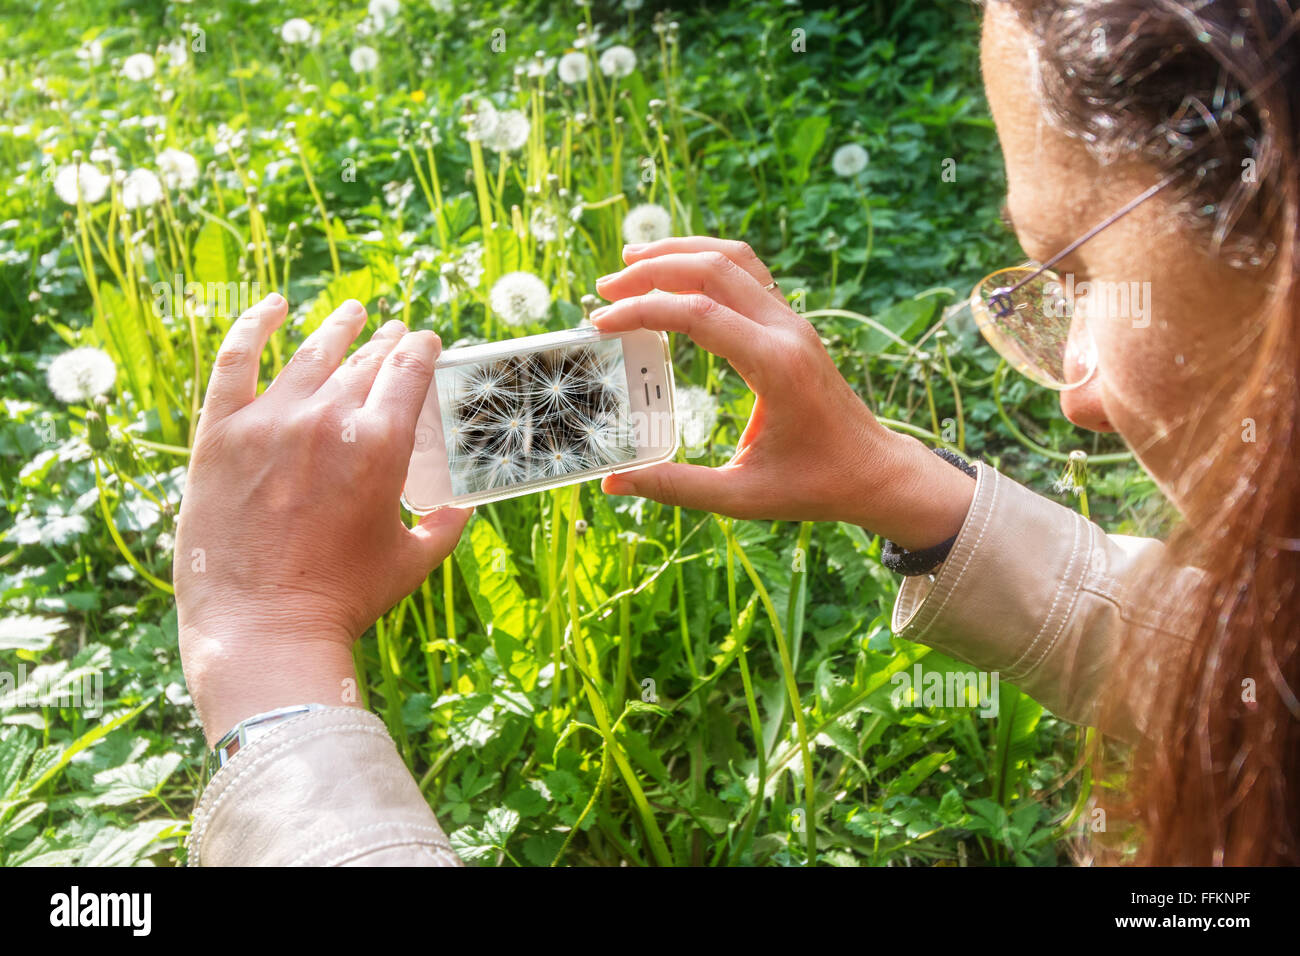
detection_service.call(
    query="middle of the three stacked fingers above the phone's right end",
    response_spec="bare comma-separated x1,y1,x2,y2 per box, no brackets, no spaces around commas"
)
595,252,777,325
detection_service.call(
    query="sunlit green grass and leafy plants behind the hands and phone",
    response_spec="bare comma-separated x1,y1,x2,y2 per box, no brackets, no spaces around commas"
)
0,0,1158,866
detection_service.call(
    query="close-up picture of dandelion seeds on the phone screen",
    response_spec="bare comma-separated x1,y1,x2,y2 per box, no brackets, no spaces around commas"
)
438,341,636,496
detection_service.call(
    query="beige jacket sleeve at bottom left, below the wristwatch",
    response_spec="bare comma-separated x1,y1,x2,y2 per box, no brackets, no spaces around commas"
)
190,706,462,866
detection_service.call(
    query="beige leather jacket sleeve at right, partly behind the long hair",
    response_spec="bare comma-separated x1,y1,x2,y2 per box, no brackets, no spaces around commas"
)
893,463,1200,740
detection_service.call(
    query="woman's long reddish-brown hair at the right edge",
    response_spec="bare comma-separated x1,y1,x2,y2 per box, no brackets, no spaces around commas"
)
1009,0,1300,865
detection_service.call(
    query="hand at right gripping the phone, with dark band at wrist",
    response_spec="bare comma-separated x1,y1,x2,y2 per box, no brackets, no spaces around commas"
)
592,237,975,550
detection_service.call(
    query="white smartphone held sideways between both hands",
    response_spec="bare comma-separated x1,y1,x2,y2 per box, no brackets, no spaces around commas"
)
402,326,677,514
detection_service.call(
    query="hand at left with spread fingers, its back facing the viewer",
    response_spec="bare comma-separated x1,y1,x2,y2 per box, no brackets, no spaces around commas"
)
173,295,469,743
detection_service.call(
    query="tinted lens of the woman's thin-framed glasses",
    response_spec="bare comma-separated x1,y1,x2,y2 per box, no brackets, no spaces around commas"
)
970,265,1097,392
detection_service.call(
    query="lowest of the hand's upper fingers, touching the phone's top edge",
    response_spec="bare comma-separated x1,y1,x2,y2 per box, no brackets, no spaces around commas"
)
592,293,781,390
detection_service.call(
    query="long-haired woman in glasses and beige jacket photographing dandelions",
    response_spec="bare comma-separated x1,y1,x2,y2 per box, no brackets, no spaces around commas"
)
176,0,1300,864
